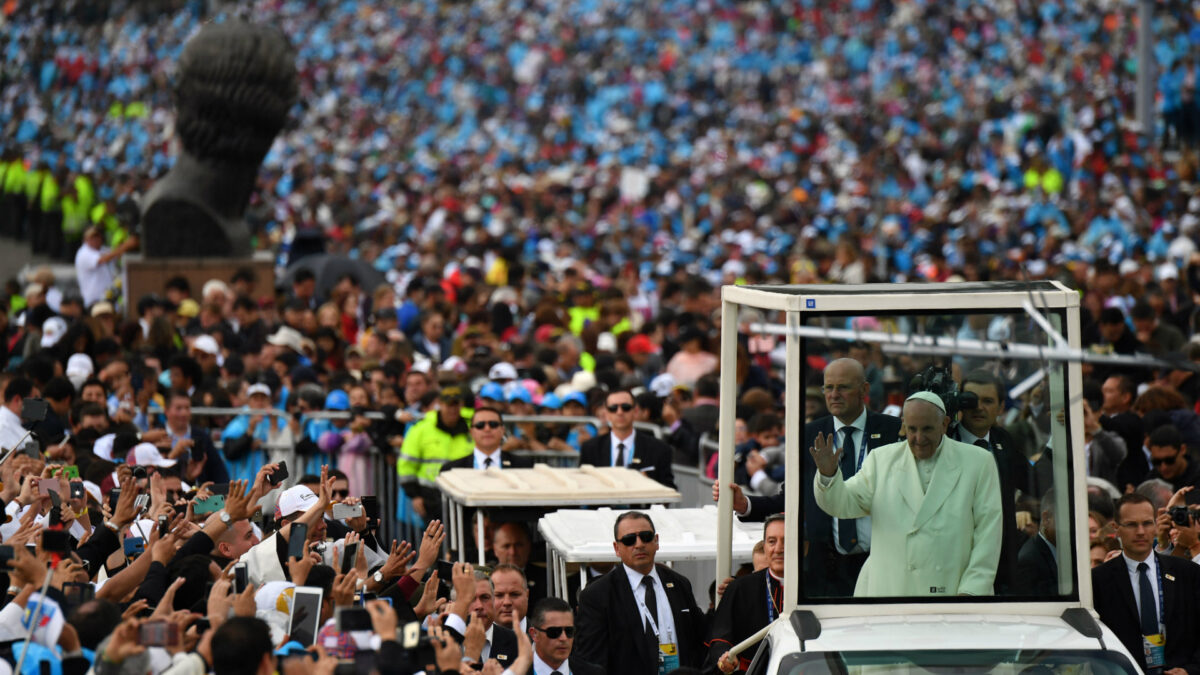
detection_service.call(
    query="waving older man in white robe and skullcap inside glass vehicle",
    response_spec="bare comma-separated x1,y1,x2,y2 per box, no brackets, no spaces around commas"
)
810,392,1002,597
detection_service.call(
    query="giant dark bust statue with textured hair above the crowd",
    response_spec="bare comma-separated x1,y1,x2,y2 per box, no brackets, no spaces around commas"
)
142,20,296,258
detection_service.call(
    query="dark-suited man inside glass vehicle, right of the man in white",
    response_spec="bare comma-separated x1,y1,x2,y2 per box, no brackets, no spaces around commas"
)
950,370,1030,595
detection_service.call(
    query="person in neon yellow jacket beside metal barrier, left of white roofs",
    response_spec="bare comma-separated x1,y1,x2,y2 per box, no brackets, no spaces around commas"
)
396,387,474,522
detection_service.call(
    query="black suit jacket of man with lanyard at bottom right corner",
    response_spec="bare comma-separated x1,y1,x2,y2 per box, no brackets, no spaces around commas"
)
1092,554,1200,675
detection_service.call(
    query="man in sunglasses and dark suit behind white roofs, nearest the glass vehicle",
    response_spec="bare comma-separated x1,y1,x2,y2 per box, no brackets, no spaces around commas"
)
580,389,674,489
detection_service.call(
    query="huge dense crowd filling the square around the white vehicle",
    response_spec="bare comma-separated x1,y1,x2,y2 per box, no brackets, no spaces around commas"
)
0,0,1200,675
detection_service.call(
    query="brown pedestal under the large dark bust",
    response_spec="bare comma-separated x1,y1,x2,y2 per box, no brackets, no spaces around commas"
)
122,251,275,318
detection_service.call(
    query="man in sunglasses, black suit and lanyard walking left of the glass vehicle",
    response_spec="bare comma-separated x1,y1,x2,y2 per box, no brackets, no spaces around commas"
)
575,512,708,675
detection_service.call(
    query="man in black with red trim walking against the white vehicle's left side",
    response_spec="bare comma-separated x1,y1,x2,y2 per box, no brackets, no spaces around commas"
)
704,513,784,673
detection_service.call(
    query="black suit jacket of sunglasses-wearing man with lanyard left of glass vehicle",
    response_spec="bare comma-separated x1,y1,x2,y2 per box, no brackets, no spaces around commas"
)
571,565,708,675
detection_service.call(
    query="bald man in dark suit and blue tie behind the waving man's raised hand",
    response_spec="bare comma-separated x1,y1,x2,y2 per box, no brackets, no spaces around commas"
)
713,358,900,597
